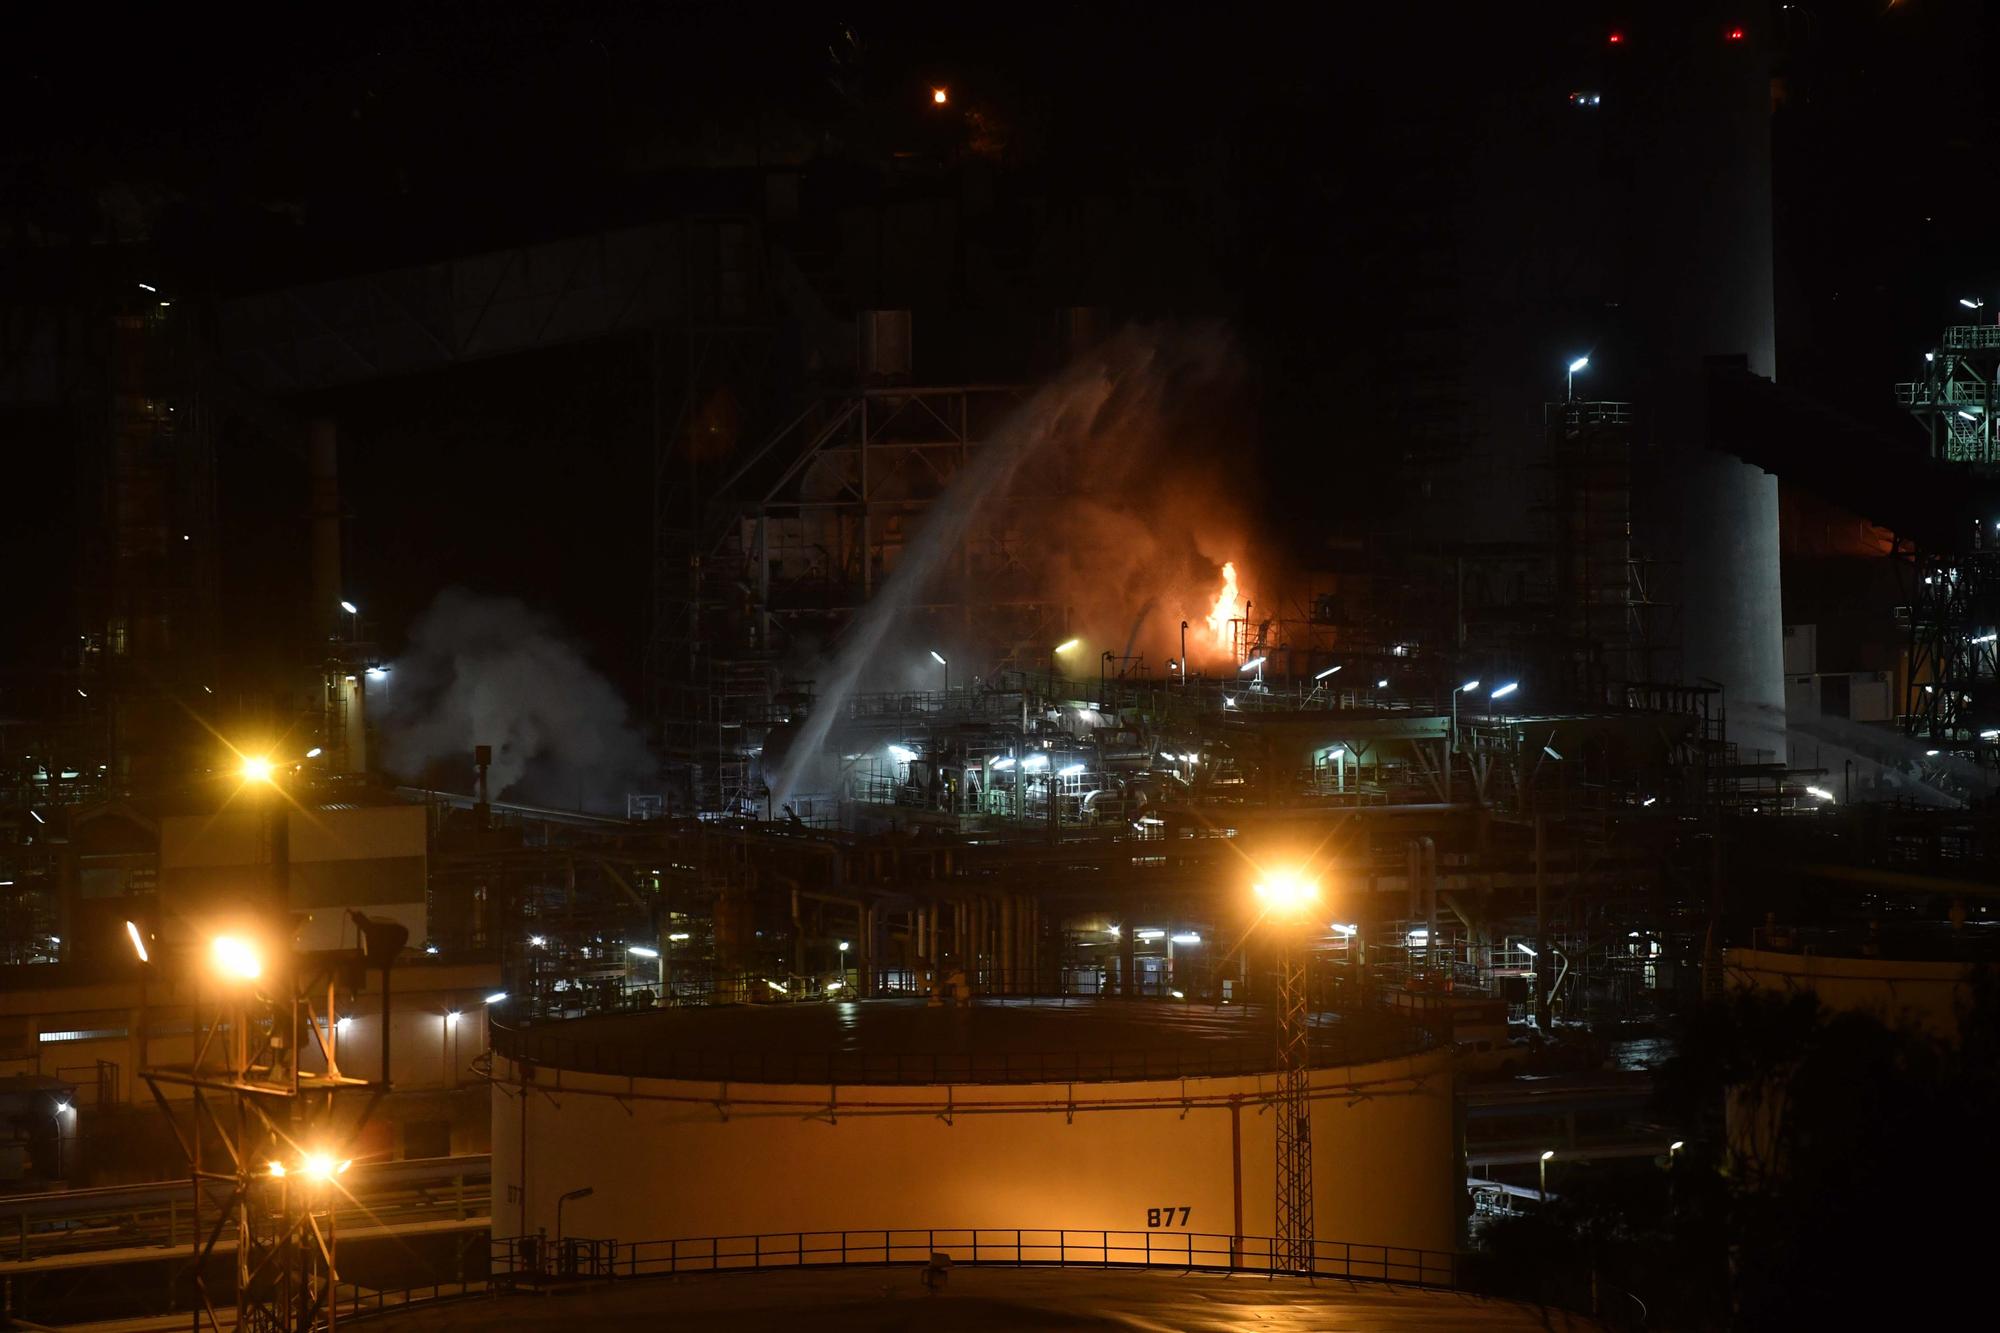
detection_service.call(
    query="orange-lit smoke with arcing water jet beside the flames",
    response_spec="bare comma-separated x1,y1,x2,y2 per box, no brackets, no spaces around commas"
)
766,328,1248,805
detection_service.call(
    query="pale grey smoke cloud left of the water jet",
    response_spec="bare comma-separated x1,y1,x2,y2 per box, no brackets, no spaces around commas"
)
368,588,658,815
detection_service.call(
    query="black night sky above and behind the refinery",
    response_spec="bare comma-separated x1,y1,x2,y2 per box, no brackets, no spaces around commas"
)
0,0,2000,700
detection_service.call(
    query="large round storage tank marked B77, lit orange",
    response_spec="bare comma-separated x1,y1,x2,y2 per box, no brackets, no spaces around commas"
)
494,999,1462,1267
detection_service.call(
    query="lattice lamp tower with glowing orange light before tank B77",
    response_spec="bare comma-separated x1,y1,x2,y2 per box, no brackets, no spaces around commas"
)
1256,871,1320,1273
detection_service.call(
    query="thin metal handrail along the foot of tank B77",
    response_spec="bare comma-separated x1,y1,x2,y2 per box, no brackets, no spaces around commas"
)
490,1227,1458,1287
